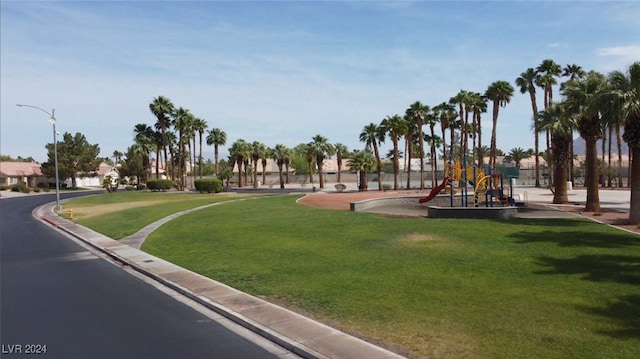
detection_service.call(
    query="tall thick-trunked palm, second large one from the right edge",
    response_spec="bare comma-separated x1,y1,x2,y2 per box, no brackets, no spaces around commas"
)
561,71,606,212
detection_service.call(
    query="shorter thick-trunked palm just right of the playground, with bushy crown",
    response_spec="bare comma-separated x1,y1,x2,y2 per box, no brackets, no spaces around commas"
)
538,103,575,204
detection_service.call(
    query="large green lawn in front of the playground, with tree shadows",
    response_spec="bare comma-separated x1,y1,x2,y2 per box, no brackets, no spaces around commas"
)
65,195,640,358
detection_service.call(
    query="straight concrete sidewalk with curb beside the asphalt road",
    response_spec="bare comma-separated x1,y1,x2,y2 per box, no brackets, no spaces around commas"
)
33,203,403,359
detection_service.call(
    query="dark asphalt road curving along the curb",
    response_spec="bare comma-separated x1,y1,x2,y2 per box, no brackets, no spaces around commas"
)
0,195,292,359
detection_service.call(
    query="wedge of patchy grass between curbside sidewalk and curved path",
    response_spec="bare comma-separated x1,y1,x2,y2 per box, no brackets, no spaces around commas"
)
62,191,262,239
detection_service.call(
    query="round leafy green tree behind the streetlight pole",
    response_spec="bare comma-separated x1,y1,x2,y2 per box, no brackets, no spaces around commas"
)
42,132,102,188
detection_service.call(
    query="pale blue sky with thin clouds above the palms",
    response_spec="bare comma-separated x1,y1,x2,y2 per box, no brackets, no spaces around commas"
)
0,0,640,161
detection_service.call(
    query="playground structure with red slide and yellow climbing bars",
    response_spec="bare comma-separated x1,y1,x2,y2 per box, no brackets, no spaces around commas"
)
418,156,524,208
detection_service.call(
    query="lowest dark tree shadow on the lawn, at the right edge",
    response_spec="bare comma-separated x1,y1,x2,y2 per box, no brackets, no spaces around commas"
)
579,295,640,339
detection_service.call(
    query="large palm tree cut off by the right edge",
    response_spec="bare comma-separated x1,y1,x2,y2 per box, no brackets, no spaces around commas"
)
599,61,640,224
